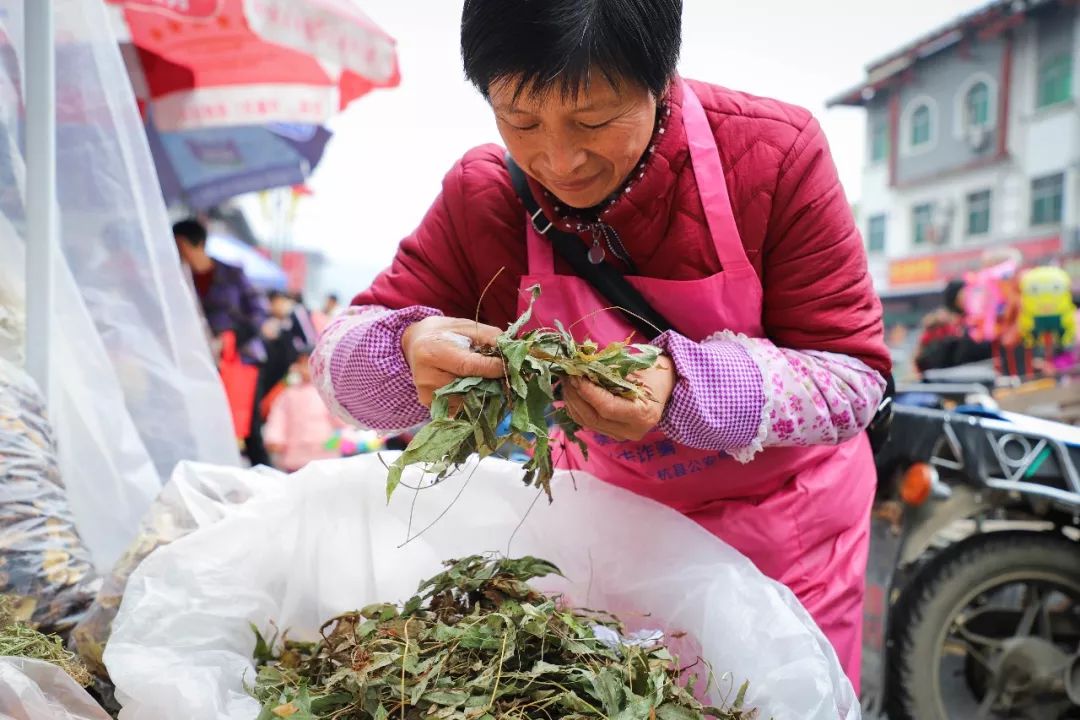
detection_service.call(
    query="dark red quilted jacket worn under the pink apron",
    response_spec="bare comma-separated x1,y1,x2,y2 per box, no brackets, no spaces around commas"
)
353,81,890,373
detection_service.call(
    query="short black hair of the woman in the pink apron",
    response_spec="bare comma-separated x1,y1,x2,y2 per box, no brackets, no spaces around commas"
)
461,0,683,97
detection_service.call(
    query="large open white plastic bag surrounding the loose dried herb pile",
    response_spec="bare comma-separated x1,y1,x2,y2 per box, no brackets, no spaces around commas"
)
105,456,859,720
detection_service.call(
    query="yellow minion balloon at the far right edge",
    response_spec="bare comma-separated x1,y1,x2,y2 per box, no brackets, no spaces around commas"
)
1020,267,1077,348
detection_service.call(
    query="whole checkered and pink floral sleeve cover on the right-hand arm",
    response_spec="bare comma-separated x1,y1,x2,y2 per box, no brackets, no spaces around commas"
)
654,331,886,462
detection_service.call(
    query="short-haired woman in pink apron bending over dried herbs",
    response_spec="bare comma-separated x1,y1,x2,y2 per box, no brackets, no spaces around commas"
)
313,0,890,682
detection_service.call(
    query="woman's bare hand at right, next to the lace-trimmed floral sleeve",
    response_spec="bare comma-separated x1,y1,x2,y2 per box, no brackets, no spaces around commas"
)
563,355,678,440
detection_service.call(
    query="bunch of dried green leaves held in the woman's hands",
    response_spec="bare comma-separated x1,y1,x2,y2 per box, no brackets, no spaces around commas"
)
387,285,660,498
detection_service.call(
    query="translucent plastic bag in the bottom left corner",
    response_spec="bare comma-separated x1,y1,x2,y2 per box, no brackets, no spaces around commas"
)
0,657,109,720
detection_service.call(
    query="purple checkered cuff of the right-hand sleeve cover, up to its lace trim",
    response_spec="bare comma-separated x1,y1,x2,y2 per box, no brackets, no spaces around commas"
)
656,331,765,451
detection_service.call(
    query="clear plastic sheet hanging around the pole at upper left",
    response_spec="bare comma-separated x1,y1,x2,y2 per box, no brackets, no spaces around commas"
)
0,0,239,569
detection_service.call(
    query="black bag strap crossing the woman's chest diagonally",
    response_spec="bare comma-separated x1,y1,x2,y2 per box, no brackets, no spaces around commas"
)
507,153,673,339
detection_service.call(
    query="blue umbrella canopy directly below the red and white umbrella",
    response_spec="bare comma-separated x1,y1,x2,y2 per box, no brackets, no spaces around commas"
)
147,121,330,209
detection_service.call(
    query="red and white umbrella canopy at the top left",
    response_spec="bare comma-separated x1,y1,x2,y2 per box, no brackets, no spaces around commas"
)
109,0,401,131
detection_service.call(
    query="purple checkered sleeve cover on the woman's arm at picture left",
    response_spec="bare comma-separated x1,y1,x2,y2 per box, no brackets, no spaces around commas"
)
311,305,441,432
